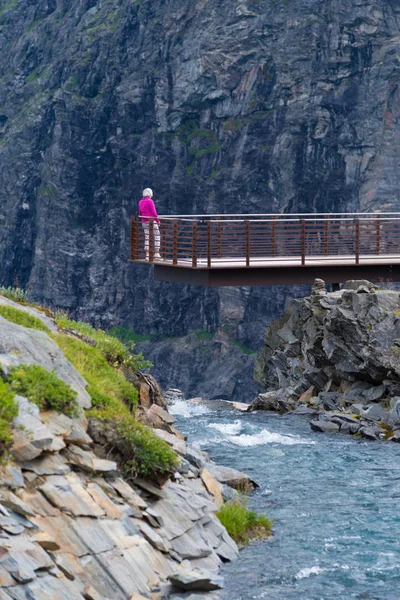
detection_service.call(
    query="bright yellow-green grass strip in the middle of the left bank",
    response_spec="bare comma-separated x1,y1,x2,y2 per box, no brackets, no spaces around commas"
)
52,334,138,408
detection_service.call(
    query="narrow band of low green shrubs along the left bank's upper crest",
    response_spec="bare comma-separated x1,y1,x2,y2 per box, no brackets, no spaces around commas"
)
56,313,152,371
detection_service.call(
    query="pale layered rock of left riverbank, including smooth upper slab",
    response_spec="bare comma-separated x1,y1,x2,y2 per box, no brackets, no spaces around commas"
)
0,297,247,600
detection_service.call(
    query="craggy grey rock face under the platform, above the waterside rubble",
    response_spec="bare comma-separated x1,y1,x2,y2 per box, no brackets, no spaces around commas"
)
255,290,400,394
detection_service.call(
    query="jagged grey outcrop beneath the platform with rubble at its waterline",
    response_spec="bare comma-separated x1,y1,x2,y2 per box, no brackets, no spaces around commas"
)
255,281,400,441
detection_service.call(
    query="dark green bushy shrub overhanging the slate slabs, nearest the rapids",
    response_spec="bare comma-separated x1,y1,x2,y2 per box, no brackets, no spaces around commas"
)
89,405,178,478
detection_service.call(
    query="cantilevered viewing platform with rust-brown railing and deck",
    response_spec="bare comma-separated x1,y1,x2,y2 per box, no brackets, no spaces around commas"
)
130,213,400,286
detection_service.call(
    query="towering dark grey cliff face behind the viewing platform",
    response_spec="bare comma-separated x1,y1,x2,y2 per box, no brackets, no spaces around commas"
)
0,0,400,348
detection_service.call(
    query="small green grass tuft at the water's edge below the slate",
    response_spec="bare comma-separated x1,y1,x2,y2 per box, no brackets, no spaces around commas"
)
217,499,273,544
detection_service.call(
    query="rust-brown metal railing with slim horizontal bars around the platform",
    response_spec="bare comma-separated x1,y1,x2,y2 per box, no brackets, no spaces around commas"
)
131,213,400,268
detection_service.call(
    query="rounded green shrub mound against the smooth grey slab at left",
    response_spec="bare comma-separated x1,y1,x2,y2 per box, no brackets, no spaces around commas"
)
7,365,79,417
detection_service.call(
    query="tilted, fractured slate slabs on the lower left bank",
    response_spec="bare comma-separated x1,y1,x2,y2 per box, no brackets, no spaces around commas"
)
0,378,238,600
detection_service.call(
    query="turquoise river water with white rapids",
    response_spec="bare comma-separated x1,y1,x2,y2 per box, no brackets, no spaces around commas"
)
172,402,400,600
